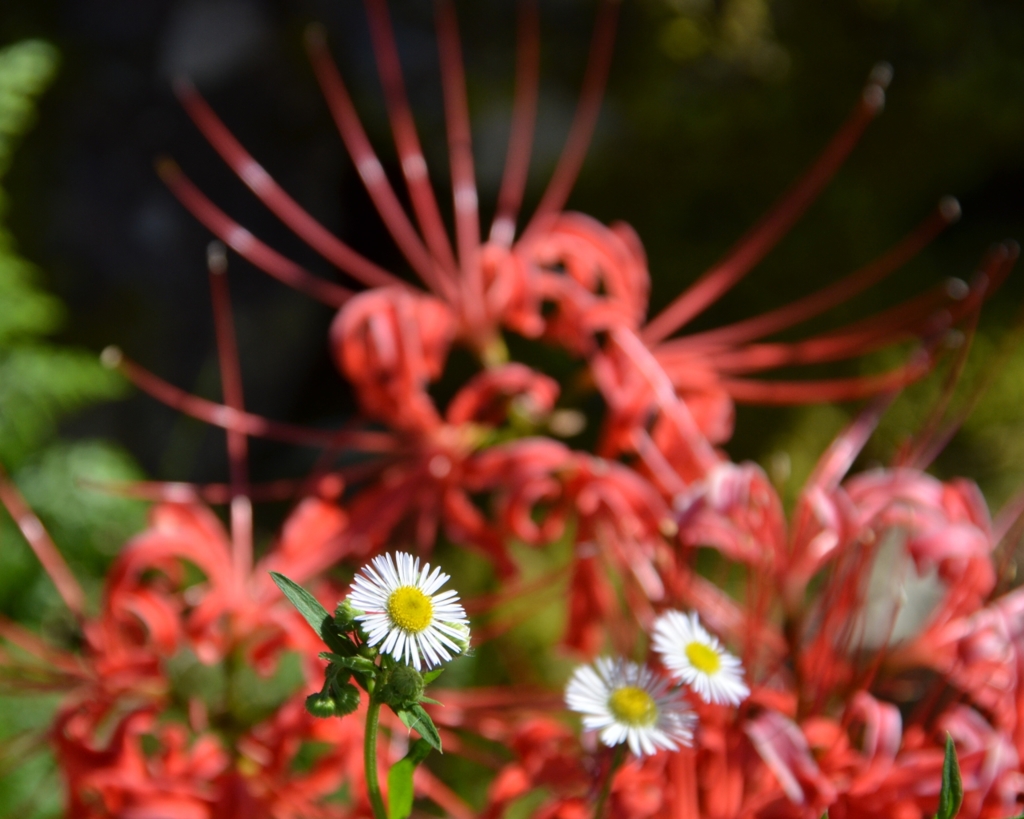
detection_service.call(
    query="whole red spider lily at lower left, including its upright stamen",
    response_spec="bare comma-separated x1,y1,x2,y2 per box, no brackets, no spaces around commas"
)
0,250,385,819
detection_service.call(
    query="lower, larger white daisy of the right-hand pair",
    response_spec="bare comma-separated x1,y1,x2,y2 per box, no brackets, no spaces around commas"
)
565,657,697,757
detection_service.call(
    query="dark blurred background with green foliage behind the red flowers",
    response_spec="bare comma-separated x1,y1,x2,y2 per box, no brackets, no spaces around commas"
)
0,0,1024,815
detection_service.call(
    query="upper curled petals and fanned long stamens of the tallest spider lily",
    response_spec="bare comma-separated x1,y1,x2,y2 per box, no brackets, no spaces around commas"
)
155,0,1009,493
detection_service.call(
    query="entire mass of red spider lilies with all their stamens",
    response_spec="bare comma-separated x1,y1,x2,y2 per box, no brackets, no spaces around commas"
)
2,0,1024,819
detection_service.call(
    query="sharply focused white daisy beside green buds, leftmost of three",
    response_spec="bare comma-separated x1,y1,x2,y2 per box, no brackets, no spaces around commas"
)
348,552,469,671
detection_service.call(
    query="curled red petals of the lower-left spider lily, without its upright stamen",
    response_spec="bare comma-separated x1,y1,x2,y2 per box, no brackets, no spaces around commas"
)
3,460,372,819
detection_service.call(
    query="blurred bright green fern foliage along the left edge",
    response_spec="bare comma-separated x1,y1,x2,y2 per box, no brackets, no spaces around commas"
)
0,35,144,622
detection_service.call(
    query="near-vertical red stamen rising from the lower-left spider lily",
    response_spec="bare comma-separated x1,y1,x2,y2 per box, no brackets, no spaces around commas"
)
207,242,253,584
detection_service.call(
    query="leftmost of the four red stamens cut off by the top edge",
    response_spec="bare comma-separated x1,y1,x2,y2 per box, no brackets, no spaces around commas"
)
365,0,459,281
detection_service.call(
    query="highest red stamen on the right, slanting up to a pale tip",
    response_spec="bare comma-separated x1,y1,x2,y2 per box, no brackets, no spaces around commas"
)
641,67,891,344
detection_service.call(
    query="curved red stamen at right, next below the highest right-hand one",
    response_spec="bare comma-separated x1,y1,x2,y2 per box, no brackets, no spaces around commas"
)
666,197,959,349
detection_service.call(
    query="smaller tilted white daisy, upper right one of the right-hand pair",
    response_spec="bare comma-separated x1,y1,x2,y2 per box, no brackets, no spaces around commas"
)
654,611,751,705
